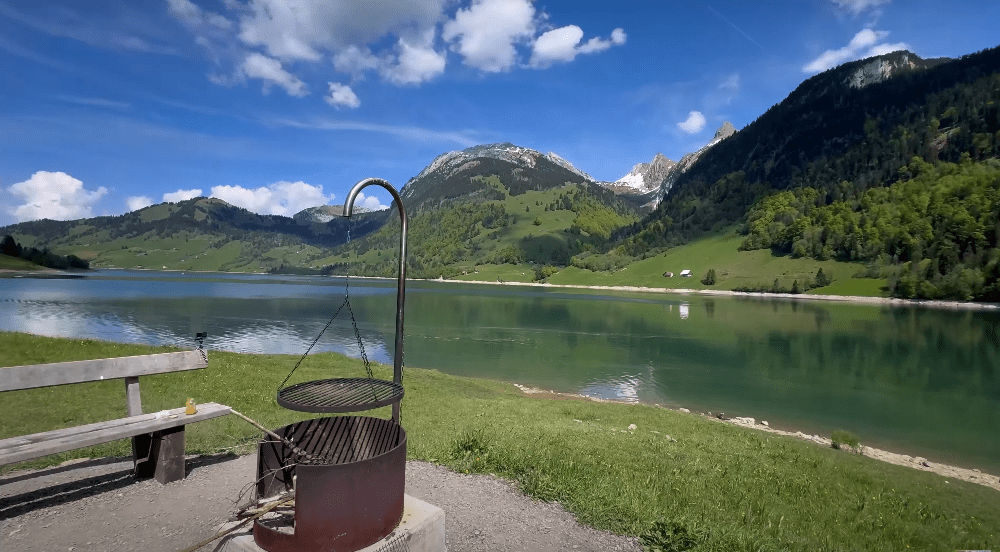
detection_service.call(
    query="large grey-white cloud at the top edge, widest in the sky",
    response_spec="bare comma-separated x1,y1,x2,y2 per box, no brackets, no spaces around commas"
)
239,0,445,61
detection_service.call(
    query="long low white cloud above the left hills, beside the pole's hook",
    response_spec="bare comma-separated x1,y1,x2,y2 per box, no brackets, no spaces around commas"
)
212,180,334,217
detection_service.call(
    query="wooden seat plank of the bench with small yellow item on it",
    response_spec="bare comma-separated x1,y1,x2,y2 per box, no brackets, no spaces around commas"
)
0,403,232,466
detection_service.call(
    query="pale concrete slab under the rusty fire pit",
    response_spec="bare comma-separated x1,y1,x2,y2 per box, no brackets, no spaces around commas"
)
213,495,448,552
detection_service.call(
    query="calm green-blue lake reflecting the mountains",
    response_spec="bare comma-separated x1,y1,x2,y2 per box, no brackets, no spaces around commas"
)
0,270,1000,473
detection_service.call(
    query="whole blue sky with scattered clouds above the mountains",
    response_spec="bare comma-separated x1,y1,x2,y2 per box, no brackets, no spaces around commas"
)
0,0,1000,225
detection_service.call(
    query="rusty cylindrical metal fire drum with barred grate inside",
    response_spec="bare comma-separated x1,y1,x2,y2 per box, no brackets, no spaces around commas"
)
253,416,406,552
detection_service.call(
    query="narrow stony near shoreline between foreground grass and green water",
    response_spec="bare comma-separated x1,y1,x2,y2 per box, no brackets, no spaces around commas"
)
511,383,1000,491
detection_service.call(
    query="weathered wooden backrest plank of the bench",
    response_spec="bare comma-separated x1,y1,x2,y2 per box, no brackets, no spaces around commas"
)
0,350,208,391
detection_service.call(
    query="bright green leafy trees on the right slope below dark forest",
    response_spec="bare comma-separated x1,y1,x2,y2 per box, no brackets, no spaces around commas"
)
740,155,1000,301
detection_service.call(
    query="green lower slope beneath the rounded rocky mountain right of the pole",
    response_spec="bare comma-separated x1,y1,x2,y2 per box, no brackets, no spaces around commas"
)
316,175,638,281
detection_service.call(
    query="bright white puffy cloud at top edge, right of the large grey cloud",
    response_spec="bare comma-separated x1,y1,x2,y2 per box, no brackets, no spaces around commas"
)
441,0,535,73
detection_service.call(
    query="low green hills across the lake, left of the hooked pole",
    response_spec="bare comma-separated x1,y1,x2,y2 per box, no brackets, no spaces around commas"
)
0,198,388,272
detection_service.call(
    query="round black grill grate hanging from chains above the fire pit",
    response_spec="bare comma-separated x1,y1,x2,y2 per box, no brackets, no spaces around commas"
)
278,378,403,412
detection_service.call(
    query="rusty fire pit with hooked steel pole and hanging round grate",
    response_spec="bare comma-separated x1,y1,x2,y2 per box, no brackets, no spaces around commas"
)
253,178,407,552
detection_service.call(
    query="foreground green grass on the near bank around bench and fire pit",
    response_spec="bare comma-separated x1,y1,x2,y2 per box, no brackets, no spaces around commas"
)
0,333,1000,552
